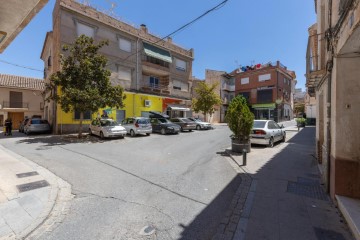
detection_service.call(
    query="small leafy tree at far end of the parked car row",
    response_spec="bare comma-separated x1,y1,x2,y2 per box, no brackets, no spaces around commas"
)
192,82,222,120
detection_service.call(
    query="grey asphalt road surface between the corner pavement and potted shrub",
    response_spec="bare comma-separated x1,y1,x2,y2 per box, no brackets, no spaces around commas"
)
0,126,241,240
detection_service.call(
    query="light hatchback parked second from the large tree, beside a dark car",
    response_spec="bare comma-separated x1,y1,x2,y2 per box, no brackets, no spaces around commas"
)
121,117,152,137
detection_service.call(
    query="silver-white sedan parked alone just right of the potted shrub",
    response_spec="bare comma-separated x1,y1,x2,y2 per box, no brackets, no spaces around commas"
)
250,120,286,147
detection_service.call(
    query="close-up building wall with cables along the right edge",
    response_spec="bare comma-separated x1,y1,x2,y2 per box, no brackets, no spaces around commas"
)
306,0,360,202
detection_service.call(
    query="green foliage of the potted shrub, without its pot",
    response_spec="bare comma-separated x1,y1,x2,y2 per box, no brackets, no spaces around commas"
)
225,95,254,142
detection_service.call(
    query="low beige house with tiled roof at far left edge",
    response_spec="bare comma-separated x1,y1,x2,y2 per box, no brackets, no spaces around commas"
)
0,74,45,129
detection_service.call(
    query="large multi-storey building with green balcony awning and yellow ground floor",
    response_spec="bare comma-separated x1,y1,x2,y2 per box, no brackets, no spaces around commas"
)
41,0,194,133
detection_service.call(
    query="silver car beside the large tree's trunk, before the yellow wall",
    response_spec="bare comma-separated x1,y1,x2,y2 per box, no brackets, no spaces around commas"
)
89,119,126,138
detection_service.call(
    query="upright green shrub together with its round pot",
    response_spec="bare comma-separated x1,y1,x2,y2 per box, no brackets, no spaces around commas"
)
225,95,254,153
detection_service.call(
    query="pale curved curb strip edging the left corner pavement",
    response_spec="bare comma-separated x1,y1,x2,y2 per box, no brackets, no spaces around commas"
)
0,145,73,240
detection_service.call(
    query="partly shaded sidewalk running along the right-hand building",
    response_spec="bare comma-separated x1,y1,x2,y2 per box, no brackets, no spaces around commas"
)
213,126,354,240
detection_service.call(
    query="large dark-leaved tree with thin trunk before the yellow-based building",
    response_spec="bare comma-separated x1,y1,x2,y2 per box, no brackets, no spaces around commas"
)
46,35,125,138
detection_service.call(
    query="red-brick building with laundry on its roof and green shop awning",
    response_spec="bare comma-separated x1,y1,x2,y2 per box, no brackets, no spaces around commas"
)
232,61,296,122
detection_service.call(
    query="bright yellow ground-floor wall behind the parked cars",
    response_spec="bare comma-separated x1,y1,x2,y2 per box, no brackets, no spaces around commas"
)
57,92,163,124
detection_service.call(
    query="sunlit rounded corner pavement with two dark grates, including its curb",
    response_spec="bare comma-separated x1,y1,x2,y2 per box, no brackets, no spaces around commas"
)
0,145,72,240
